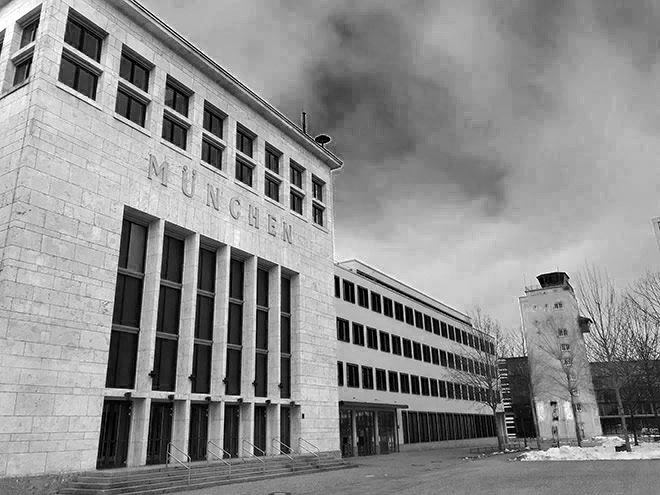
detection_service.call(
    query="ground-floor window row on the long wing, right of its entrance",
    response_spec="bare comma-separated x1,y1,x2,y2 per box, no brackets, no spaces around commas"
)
401,411,496,443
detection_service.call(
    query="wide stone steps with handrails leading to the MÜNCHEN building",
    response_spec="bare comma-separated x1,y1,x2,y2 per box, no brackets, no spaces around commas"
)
59,452,354,495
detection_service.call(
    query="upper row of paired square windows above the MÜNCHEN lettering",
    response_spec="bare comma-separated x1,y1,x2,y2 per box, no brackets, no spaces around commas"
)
8,6,326,226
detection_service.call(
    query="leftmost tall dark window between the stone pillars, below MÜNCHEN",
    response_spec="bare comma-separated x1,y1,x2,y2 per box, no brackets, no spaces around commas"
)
105,220,147,388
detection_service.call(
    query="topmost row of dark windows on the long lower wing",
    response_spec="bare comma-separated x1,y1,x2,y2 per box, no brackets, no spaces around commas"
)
335,276,495,354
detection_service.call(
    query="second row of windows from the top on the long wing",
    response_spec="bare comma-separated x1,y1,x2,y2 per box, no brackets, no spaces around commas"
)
337,318,497,376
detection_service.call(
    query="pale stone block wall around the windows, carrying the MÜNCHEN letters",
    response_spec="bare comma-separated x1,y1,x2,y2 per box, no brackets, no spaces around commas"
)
0,0,341,476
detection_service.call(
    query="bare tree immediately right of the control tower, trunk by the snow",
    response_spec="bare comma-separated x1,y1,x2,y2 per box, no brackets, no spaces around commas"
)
577,265,631,452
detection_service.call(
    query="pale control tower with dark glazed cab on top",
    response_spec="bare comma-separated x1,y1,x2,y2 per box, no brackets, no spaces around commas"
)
520,272,601,439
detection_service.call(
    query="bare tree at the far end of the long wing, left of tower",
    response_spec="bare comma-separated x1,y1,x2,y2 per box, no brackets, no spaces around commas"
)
455,308,506,451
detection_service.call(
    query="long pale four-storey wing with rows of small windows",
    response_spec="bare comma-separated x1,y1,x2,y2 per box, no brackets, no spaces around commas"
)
335,260,495,456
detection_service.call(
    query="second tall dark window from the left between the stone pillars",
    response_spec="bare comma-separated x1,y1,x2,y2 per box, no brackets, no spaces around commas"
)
152,234,184,392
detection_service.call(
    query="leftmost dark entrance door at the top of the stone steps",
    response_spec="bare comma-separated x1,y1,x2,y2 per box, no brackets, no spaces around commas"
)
96,400,131,469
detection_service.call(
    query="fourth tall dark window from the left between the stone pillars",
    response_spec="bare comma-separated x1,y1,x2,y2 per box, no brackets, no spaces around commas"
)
225,259,245,395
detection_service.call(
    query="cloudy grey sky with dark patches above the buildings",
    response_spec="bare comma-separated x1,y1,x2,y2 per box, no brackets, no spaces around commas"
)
142,0,660,334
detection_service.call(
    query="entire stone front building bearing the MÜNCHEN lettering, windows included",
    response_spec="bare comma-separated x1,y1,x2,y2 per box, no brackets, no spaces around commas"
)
0,0,342,476
